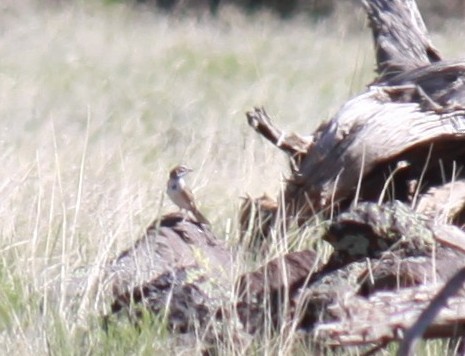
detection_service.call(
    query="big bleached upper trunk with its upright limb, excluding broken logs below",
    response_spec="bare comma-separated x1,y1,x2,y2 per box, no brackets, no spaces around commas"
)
262,0,465,222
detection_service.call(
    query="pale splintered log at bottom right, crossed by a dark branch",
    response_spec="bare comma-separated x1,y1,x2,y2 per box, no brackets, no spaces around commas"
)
315,285,465,346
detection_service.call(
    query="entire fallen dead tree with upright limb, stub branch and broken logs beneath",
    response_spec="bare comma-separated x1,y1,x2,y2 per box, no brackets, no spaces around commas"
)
241,0,465,352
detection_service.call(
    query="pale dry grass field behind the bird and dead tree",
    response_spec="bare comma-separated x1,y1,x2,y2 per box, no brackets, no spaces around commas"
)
0,0,464,355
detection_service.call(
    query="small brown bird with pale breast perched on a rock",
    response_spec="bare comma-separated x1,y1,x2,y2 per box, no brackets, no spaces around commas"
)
166,165,210,225
